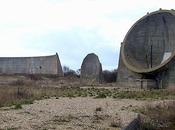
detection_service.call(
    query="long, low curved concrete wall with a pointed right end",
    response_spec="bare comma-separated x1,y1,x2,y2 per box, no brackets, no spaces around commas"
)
0,54,63,76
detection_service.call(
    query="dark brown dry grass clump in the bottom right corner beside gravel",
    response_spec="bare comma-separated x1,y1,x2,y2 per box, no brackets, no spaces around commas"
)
139,101,175,130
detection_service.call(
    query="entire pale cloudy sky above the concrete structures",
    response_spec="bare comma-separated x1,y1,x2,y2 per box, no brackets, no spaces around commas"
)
0,0,175,70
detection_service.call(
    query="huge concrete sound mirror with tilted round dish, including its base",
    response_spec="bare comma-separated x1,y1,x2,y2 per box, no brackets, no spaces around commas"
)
117,10,175,88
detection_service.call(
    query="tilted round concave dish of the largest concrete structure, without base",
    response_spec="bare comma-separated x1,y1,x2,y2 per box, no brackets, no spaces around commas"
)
121,10,175,73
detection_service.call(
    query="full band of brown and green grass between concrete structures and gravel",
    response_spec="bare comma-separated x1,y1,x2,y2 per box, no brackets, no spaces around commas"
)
0,75,175,111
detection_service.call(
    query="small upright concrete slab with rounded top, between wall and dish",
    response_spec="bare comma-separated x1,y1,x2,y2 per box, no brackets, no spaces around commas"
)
80,53,102,83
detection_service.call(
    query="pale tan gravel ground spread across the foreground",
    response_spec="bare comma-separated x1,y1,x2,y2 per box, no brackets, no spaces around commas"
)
0,97,148,130
